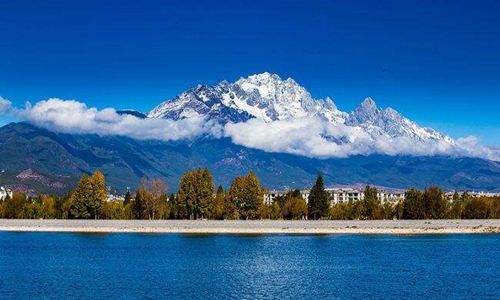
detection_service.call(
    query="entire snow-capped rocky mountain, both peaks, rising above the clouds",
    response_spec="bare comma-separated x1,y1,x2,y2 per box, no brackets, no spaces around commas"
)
148,72,455,145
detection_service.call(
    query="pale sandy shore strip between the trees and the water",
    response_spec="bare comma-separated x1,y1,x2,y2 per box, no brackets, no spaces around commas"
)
0,219,500,234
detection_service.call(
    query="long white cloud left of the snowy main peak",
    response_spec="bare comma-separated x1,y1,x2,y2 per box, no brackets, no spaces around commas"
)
16,98,220,141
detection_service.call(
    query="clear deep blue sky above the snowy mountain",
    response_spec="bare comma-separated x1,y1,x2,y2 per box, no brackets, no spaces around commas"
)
0,0,500,144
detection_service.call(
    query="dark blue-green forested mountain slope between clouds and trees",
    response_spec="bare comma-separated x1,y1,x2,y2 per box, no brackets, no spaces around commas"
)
0,123,500,193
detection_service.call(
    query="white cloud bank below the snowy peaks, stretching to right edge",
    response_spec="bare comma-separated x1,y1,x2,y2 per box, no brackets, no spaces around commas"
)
224,118,500,161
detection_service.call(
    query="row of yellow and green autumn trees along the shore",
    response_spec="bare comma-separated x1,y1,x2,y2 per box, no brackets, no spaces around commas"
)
0,168,500,220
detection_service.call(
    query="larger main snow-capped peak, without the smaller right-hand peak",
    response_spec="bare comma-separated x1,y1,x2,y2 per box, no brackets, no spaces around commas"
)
148,73,348,123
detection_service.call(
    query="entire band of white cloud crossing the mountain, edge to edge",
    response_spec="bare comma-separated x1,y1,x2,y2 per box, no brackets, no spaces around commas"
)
0,97,500,161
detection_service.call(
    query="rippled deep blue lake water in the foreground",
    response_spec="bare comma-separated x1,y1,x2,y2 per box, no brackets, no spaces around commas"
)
0,232,500,299
